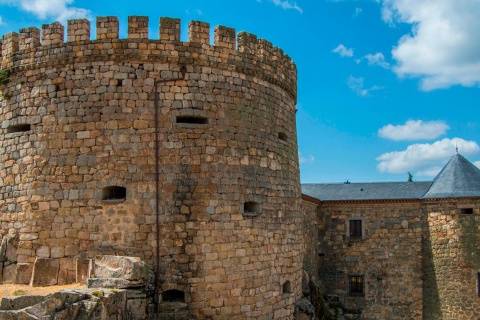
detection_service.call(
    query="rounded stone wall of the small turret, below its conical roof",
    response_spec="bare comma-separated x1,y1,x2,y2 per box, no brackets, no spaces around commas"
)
423,198,480,320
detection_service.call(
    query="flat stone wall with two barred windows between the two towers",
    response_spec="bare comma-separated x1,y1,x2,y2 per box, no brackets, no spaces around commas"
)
319,201,424,320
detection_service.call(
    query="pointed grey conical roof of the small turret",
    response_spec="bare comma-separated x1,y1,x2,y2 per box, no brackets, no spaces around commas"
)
423,153,480,198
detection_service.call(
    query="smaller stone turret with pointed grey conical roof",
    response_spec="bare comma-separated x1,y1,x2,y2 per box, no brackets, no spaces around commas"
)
422,154,480,320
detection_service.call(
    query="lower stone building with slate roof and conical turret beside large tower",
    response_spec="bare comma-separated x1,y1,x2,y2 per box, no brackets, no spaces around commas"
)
302,154,480,320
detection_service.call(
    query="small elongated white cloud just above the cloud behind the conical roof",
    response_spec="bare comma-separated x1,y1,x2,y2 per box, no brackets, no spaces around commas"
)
378,120,450,141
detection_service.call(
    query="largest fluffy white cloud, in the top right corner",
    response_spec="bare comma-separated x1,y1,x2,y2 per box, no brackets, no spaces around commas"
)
381,0,480,91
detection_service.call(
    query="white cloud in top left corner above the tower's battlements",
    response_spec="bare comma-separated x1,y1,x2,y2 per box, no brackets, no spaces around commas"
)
0,0,90,22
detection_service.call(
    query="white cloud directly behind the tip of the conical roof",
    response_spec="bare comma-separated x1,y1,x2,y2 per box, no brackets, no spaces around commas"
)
376,138,480,176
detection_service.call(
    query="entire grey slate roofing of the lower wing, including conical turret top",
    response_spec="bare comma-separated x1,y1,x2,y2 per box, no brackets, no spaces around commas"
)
302,154,480,201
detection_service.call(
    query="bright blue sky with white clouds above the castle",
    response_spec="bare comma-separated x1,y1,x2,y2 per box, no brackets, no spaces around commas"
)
0,0,480,183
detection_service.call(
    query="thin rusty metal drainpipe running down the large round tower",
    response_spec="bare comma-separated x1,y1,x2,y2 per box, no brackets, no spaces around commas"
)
153,65,187,319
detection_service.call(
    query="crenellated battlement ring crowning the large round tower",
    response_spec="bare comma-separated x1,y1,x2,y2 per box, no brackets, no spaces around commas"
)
0,16,296,96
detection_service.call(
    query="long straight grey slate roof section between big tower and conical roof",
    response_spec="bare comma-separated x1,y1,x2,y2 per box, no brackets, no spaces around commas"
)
302,181,432,201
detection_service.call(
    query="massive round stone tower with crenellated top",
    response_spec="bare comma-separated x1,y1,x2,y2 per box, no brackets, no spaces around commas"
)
0,17,303,319
